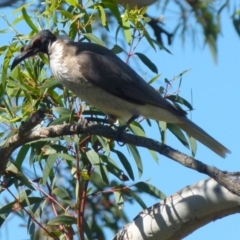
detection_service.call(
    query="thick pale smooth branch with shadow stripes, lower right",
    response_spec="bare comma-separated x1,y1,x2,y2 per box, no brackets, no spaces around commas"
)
113,175,240,240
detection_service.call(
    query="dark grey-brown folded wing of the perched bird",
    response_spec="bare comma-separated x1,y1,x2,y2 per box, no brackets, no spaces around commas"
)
78,48,186,116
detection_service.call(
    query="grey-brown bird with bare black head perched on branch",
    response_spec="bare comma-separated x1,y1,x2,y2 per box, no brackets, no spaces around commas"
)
11,30,230,158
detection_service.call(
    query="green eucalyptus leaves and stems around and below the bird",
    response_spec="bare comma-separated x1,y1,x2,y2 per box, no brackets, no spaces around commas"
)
0,0,226,239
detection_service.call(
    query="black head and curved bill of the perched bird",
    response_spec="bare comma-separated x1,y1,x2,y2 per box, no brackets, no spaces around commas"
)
11,30,57,70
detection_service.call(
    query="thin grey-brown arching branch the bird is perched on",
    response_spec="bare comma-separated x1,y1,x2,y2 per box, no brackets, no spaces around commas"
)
0,119,240,196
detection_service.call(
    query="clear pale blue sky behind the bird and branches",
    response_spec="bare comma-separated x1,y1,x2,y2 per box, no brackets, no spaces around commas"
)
0,1,240,240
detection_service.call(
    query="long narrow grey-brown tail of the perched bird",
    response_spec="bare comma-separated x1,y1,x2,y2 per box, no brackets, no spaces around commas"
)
177,118,230,158
